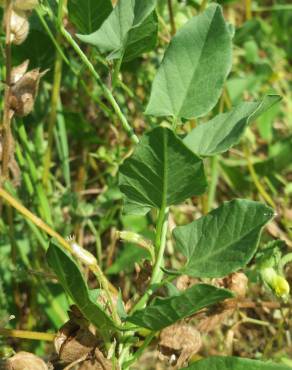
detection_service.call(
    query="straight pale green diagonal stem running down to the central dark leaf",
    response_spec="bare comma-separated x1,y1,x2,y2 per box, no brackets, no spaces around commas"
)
60,25,139,144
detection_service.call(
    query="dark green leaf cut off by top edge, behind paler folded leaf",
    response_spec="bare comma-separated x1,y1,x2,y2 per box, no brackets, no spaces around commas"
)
68,0,113,33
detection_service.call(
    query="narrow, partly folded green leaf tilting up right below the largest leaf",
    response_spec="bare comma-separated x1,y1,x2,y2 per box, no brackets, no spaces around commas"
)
183,95,281,156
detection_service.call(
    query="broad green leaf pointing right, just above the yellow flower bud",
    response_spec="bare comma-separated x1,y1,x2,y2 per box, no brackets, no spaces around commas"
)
173,199,274,277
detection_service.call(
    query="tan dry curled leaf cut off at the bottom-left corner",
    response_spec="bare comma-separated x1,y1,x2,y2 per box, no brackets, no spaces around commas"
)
5,352,48,370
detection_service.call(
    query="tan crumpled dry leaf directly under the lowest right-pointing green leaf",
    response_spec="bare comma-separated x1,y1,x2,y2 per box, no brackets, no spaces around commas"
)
159,323,202,369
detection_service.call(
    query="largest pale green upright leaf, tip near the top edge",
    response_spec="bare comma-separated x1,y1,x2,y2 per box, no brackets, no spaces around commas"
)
146,4,232,118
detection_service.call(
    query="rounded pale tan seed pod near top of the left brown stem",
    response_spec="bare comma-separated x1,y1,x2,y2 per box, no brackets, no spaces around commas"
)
10,10,29,45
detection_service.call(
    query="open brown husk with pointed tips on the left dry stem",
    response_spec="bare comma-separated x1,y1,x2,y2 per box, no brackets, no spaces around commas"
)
10,61,47,117
